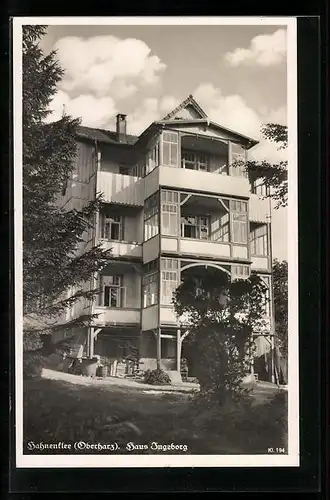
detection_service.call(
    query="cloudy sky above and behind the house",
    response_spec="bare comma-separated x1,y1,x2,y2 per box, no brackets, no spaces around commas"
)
41,25,287,260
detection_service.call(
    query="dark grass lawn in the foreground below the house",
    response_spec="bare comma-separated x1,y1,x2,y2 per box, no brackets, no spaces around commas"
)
23,378,287,454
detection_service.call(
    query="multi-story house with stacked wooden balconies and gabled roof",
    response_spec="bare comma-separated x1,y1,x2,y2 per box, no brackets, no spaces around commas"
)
56,95,273,380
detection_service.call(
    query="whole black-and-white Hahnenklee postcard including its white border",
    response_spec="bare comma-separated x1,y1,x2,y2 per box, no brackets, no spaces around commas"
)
13,17,299,468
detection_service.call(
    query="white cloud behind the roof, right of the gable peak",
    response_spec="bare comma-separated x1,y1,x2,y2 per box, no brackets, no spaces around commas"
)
193,83,286,161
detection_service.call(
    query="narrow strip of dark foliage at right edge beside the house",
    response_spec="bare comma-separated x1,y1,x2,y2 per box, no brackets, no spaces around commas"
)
273,259,288,356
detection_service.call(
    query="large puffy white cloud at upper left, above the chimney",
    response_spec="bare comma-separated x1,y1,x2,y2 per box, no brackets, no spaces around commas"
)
54,36,166,99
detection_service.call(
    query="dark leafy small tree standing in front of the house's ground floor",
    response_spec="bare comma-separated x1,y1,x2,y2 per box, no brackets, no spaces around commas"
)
173,268,266,403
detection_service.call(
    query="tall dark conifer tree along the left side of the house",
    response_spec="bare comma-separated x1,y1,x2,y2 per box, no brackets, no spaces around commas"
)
23,26,109,346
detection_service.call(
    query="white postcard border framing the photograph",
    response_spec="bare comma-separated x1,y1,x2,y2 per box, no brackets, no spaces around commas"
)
13,16,300,468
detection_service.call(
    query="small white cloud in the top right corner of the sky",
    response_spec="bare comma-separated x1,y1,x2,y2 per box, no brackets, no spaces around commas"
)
225,28,287,66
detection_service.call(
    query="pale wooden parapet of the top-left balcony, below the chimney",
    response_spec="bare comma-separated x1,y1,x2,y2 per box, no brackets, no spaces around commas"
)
96,170,144,207
